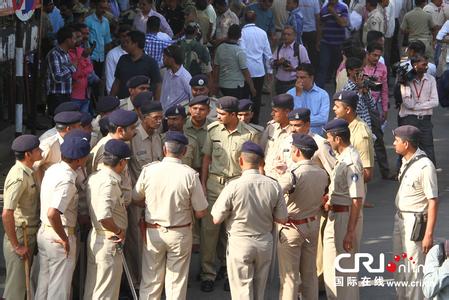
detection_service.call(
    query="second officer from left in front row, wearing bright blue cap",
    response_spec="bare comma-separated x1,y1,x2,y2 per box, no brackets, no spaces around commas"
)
35,133,90,299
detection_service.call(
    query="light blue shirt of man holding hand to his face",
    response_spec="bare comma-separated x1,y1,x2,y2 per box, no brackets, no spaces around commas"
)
287,84,330,134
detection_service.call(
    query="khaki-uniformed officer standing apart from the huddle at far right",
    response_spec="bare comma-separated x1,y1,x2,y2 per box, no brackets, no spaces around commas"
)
393,125,438,299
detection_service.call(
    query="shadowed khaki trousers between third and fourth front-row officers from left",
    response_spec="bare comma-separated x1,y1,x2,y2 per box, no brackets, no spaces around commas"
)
123,204,145,287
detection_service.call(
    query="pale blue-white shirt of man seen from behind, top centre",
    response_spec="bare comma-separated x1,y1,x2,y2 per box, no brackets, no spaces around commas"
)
240,24,273,77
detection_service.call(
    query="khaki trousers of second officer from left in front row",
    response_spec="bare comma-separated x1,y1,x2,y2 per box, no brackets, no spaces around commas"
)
34,225,76,300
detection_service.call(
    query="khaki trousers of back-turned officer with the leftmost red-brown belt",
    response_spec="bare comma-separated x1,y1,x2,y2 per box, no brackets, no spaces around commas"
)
139,226,192,300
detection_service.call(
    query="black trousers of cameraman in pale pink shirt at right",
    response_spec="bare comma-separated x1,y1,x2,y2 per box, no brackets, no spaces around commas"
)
398,115,436,166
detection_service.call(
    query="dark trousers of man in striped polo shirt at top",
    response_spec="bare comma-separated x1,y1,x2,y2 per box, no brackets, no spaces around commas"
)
315,42,341,89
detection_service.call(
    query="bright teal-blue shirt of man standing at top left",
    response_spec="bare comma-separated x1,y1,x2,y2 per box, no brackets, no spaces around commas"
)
84,14,112,62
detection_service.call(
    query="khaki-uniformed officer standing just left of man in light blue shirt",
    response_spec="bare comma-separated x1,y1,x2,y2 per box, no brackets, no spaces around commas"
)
261,94,293,177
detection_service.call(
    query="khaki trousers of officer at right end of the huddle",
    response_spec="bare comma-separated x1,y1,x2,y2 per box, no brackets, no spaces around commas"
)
323,211,363,300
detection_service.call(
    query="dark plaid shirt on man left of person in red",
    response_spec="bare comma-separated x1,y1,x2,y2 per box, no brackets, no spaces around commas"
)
47,46,76,95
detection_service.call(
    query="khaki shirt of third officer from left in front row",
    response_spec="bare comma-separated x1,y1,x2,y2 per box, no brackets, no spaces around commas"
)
87,167,128,230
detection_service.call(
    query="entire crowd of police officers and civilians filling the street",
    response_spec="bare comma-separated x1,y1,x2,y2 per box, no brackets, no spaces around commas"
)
2,0,449,299
